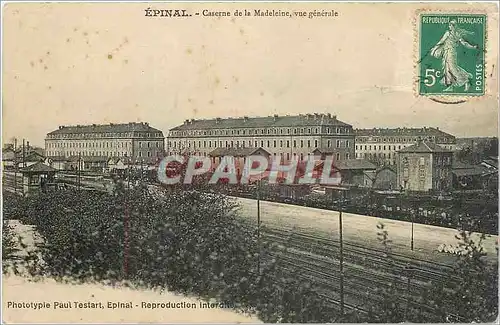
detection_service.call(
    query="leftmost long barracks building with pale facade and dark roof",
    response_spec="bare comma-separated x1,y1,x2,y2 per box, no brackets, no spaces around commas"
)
45,122,165,163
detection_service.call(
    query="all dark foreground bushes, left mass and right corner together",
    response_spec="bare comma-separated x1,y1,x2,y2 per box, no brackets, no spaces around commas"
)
2,183,498,323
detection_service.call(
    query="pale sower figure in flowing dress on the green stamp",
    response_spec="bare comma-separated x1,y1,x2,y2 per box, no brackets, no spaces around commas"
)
431,20,478,91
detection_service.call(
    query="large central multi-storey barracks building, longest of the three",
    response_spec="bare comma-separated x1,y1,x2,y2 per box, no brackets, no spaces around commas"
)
167,113,354,161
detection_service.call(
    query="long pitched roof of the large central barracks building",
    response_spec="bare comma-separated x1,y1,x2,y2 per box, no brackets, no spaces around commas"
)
170,114,351,131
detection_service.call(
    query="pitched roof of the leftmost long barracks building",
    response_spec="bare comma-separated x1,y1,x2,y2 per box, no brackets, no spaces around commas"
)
47,122,163,136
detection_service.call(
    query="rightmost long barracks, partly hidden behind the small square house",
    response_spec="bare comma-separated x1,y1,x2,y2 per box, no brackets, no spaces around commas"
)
354,127,457,165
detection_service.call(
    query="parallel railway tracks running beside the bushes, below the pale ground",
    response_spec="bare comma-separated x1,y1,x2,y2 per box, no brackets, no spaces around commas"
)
254,223,468,319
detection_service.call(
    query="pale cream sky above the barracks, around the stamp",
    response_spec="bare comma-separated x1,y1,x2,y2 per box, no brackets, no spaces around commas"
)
2,3,499,146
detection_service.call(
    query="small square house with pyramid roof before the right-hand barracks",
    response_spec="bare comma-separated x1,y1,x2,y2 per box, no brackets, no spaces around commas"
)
397,140,453,191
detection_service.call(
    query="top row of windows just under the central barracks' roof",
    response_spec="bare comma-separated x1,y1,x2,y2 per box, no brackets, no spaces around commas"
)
170,127,352,137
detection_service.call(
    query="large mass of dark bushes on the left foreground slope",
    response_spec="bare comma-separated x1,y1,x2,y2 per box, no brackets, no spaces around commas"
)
0,182,344,322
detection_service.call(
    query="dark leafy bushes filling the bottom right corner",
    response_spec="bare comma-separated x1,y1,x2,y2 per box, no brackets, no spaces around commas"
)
369,220,498,323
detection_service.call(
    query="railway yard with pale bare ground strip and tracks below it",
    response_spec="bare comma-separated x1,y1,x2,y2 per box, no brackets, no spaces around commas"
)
4,171,498,320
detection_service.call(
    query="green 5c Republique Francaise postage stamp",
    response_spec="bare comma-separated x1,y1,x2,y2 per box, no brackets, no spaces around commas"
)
418,13,486,96
